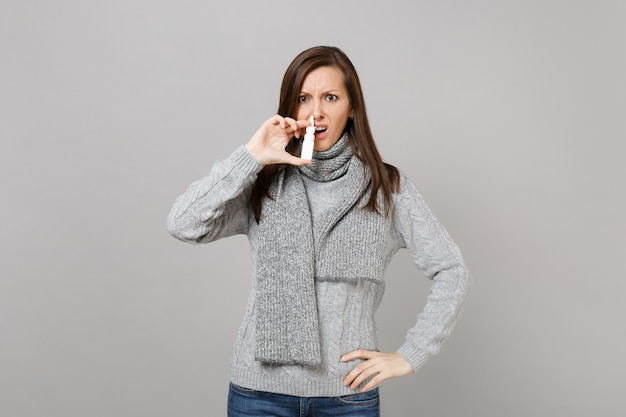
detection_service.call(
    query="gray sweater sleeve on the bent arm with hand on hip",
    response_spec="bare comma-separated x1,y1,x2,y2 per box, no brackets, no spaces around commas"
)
393,177,470,370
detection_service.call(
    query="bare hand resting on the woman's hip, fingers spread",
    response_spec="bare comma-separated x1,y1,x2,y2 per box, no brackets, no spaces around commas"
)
341,350,413,392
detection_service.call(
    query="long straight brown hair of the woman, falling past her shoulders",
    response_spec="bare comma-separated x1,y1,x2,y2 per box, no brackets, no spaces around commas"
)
250,46,400,223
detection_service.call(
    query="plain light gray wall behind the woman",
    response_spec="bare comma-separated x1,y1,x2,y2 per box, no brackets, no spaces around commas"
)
0,0,626,417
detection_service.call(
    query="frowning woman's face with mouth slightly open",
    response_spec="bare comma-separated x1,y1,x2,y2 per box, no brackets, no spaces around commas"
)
296,67,352,151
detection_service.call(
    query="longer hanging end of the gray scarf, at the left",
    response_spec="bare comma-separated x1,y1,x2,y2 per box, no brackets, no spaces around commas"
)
256,167,320,365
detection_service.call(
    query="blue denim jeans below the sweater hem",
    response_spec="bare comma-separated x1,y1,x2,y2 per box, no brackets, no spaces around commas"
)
228,384,380,417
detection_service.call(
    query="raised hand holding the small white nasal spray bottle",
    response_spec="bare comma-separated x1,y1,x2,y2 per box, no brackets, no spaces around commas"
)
246,115,311,165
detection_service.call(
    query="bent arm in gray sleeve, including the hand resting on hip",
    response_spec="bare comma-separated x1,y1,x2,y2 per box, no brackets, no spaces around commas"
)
342,177,470,391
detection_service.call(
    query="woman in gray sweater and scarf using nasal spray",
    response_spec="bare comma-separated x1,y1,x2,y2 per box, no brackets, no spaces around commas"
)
168,46,469,417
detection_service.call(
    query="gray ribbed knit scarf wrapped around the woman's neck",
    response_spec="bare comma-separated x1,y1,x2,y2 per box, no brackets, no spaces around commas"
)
256,135,385,366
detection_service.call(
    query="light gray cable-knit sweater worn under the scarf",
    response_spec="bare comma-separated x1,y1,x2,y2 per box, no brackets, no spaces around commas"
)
167,146,469,397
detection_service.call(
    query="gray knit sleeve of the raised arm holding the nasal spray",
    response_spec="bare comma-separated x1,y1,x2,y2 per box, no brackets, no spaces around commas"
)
167,146,263,244
